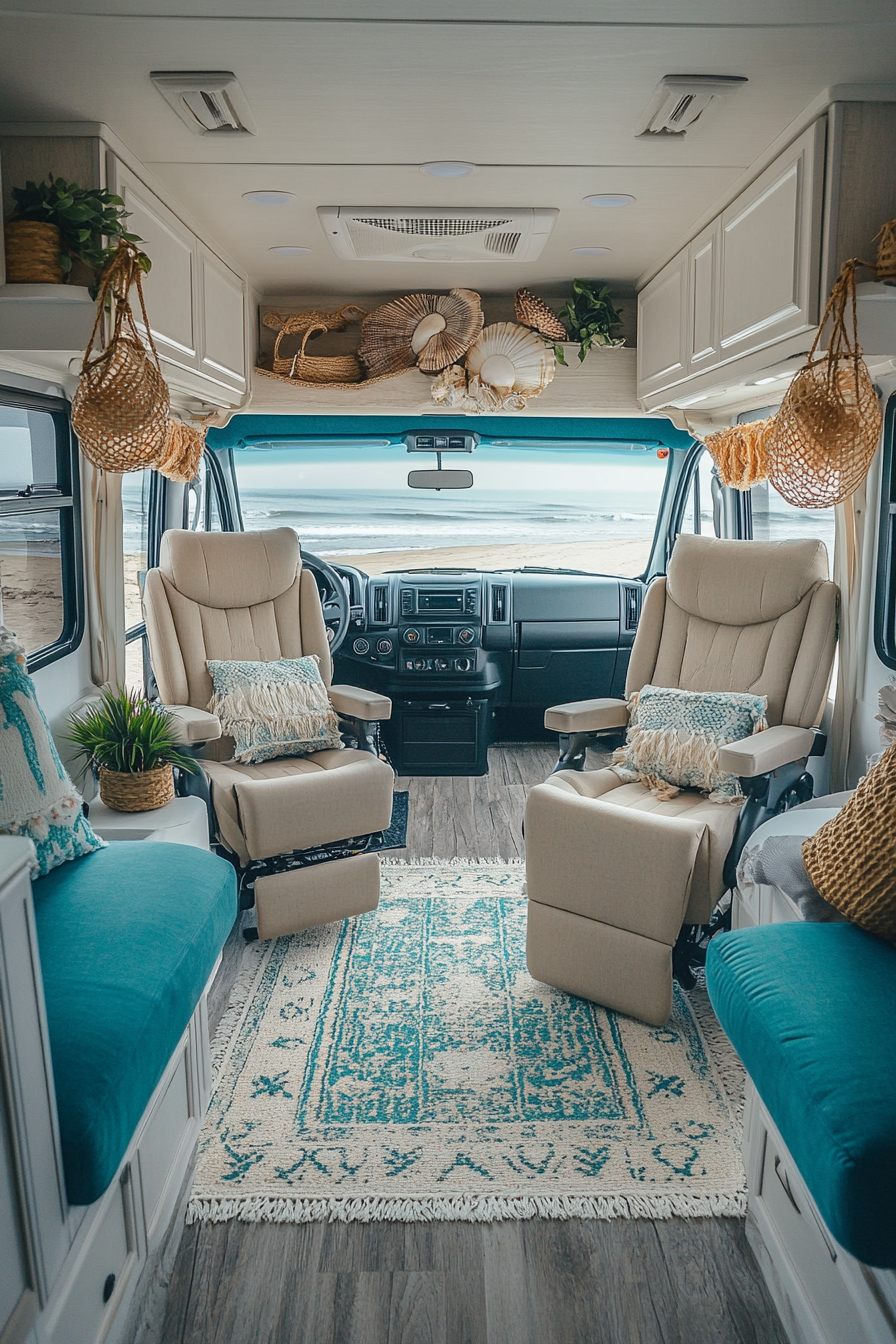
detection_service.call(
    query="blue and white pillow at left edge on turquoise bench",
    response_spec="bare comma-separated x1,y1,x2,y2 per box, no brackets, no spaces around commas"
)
0,628,105,878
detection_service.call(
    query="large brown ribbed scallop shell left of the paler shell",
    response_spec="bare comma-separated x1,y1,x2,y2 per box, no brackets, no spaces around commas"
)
359,289,482,376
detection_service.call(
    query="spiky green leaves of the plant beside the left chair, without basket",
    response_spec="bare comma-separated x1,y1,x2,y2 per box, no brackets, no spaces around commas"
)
66,687,197,774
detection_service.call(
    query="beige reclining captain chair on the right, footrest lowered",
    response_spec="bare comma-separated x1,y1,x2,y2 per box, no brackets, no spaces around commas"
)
525,536,838,1025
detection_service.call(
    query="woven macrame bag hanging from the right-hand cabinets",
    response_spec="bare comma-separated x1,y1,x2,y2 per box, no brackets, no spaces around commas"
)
766,258,883,508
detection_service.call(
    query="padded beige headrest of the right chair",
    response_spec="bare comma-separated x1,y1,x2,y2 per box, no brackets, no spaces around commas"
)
666,535,827,625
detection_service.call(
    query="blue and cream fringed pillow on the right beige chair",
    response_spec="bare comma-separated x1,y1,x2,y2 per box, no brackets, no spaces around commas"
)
613,685,768,802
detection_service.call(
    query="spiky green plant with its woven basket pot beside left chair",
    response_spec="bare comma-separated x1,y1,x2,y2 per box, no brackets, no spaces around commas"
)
67,687,197,812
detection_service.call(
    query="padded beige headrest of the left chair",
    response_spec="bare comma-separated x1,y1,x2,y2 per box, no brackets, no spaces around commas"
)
159,527,302,609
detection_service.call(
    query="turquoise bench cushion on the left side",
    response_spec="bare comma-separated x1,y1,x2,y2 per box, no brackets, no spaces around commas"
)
32,841,236,1204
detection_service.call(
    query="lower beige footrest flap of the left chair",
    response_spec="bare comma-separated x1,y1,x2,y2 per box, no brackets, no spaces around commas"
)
246,853,380,938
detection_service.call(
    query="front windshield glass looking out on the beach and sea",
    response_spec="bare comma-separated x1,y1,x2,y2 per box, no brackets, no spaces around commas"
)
234,444,668,577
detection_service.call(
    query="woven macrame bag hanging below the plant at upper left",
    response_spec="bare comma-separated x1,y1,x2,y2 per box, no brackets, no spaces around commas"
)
71,239,169,472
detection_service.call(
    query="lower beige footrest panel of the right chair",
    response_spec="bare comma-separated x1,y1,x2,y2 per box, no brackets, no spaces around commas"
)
525,900,672,1027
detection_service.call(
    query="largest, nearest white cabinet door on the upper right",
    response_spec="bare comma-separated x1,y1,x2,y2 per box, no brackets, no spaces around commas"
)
719,120,825,362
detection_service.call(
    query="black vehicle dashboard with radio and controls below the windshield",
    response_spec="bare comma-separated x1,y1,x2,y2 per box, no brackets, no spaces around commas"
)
334,564,645,708
